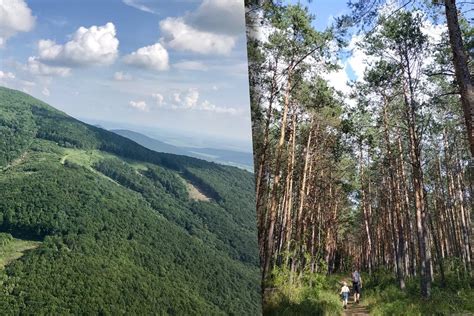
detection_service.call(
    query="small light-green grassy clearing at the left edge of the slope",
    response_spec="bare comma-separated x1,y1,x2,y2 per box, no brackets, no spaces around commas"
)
0,233,41,270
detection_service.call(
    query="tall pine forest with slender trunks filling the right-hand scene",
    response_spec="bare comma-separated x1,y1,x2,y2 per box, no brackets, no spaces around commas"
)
247,0,474,315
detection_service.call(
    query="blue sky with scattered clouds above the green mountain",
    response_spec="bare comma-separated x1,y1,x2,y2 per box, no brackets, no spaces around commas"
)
0,0,251,150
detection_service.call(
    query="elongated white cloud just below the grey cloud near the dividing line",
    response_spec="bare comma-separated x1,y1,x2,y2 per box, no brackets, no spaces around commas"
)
160,18,236,55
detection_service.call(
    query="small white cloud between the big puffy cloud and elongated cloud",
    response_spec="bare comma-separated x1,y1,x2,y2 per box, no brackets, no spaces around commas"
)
123,43,169,71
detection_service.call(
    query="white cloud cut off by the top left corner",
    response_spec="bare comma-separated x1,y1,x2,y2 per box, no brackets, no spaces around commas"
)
0,0,35,48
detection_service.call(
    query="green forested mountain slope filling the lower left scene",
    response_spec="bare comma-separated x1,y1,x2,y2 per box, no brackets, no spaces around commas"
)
0,88,260,315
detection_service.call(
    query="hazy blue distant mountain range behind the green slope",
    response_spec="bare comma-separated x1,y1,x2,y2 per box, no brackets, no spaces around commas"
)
111,129,253,171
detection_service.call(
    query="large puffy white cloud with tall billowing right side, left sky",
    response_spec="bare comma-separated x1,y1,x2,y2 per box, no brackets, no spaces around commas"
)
38,22,119,67
